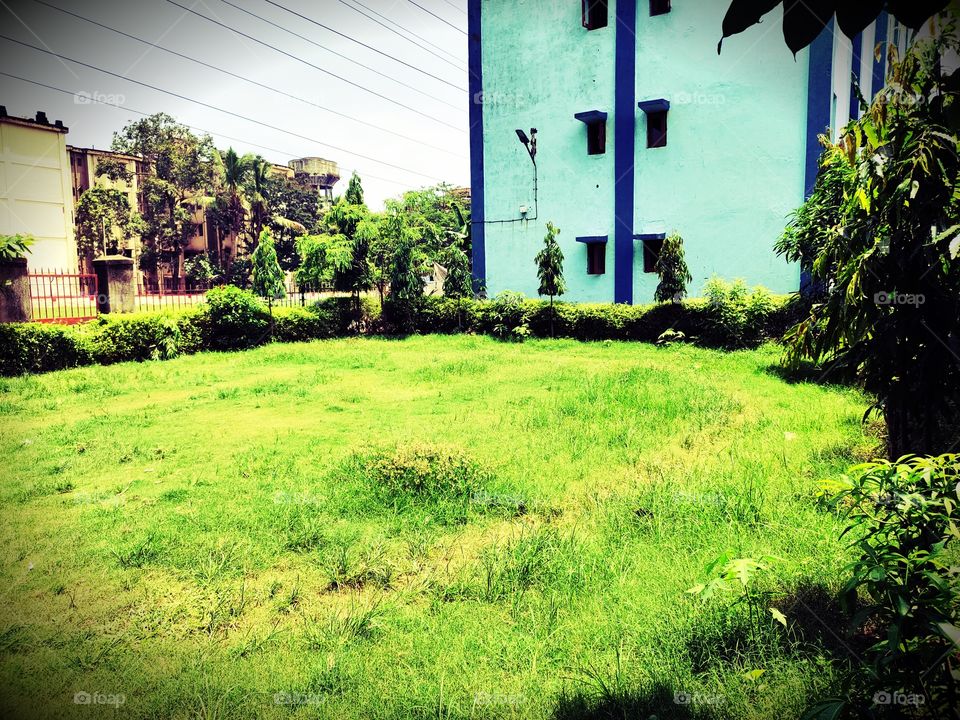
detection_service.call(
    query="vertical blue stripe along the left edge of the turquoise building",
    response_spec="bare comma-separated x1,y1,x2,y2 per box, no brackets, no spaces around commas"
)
467,0,487,290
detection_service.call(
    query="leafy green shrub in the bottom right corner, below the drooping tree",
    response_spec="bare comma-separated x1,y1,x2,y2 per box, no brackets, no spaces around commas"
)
825,455,960,717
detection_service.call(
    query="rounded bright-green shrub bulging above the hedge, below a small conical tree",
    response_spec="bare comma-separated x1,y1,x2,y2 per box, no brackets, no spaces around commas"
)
204,285,270,350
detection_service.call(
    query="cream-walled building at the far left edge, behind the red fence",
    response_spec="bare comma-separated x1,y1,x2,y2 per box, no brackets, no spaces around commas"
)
0,106,77,272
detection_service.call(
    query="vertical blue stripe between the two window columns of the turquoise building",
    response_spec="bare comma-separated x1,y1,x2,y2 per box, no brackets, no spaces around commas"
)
613,0,637,304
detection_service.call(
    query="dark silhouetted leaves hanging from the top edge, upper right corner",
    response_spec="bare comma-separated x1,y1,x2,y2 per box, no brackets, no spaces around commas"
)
717,0,950,55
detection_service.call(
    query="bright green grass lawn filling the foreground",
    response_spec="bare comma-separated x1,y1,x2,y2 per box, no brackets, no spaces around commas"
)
0,337,877,720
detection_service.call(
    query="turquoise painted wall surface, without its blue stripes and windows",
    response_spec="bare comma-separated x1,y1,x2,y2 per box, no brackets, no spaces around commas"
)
474,0,808,303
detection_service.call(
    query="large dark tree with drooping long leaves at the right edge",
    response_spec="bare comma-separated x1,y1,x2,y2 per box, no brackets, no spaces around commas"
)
778,27,960,459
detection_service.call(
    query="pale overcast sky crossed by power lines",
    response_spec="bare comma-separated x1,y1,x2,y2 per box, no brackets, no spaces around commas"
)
0,0,469,209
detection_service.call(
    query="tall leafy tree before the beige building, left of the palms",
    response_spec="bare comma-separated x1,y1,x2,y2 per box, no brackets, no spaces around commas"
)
112,113,216,286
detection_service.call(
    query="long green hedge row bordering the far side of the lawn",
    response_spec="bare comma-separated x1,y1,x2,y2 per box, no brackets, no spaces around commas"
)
0,286,791,376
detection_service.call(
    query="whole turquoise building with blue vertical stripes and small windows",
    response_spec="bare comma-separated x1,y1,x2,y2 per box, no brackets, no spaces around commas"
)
468,0,905,303
